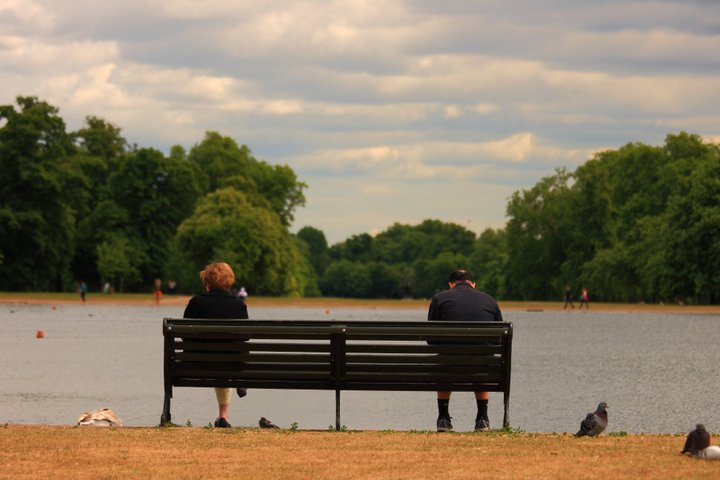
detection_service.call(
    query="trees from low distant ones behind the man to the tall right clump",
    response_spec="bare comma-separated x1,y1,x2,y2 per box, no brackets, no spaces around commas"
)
298,132,720,304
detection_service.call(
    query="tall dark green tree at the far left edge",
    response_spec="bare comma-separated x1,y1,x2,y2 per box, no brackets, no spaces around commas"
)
0,97,89,290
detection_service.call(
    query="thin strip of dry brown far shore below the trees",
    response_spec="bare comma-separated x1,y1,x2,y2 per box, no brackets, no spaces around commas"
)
0,292,720,315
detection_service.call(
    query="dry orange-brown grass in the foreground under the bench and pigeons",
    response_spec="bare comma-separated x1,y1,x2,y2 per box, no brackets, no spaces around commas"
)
0,425,720,480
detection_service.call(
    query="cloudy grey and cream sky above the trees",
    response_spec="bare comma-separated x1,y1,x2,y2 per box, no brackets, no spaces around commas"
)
0,0,720,244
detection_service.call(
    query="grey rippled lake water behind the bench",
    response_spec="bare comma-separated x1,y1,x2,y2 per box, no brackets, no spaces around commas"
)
0,303,720,433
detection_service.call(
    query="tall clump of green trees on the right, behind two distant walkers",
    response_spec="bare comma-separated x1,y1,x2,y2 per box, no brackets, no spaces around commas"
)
506,132,720,303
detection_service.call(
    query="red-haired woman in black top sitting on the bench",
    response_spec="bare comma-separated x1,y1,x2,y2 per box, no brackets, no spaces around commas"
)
183,262,249,428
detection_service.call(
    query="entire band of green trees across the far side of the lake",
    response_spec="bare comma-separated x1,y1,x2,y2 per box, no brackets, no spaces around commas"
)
0,97,720,303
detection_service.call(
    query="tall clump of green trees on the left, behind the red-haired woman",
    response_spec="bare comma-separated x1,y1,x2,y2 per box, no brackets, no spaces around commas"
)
0,97,311,295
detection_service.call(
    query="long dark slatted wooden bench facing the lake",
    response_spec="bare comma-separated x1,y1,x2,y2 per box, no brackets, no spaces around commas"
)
160,318,513,430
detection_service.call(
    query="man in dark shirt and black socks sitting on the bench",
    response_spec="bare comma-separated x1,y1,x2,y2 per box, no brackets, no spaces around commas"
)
428,270,503,432
